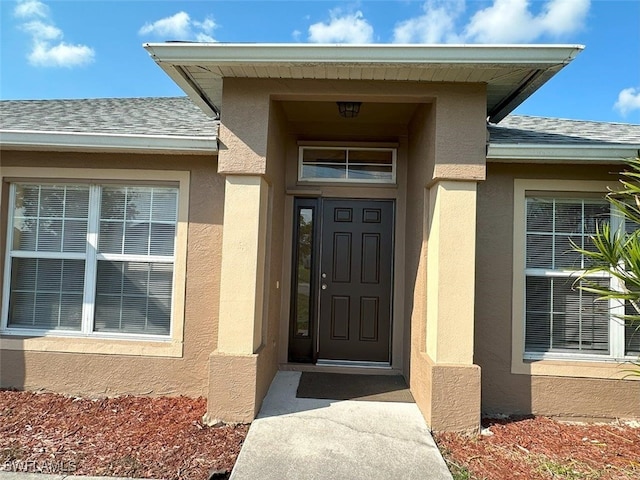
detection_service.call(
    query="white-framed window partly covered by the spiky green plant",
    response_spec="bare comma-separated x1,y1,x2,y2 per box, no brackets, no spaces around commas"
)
523,192,640,360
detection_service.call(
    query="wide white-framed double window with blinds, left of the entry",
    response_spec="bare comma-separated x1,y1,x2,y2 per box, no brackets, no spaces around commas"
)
1,181,178,339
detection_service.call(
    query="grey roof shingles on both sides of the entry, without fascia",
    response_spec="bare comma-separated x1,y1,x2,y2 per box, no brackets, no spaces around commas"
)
0,97,640,146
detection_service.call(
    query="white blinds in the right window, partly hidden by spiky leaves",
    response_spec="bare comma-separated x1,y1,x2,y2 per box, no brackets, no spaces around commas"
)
525,198,610,355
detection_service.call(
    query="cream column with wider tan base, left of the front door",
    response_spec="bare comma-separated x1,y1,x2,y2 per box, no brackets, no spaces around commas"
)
204,175,269,423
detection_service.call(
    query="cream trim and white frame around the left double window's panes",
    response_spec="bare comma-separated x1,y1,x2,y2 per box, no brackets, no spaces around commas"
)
0,167,190,357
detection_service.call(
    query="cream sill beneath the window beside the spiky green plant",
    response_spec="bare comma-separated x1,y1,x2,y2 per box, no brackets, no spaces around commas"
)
511,356,640,381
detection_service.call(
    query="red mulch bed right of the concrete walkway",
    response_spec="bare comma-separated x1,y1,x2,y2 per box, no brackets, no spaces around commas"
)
435,417,640,480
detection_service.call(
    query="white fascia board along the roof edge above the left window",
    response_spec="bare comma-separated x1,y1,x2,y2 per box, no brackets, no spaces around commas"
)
0,130,218,154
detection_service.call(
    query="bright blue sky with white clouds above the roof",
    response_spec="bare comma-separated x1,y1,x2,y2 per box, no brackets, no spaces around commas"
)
0,0,640,124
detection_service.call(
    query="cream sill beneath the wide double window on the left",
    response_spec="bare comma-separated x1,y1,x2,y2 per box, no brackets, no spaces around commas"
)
0,333,182,358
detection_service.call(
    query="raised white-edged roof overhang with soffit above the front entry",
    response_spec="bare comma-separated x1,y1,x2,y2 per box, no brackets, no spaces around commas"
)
144,42,584,123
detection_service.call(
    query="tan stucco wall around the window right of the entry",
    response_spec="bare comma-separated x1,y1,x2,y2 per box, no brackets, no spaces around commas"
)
474,163,640,418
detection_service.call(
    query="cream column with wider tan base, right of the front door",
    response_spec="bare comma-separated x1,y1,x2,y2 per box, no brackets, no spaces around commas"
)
411,180,481,432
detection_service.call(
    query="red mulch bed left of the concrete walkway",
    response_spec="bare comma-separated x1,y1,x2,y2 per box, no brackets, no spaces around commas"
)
0,391,248,480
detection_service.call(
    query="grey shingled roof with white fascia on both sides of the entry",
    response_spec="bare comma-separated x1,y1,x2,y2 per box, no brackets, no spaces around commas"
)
0,97,640,160
